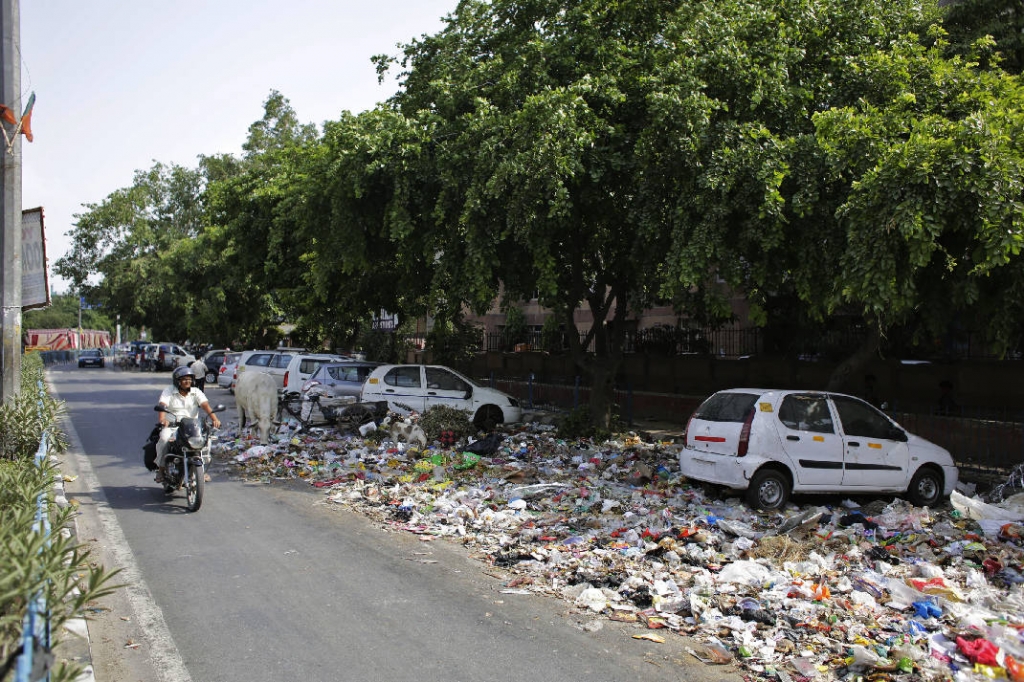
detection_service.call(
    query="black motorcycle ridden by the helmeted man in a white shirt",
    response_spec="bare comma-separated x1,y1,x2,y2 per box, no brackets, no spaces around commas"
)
143,404,227,511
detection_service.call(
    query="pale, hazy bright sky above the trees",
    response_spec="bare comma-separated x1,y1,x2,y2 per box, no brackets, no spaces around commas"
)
19,0,458,293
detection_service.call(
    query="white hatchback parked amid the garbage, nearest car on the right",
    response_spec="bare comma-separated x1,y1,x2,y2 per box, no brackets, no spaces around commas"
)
679,388,959,509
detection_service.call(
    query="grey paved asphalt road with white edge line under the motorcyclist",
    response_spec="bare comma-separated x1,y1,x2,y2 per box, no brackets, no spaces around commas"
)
48,367,738,682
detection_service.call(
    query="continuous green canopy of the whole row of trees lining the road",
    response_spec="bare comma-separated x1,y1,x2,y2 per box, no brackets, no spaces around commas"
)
58,0,1024,422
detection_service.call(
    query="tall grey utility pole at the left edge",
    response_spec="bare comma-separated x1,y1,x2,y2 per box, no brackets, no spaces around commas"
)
0,0,22,403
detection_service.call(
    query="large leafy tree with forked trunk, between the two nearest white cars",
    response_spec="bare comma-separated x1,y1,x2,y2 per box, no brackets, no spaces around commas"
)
379,0,700,424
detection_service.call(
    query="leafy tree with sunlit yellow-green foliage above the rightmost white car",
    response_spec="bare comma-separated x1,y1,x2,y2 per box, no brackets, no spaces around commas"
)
647,0,1022,388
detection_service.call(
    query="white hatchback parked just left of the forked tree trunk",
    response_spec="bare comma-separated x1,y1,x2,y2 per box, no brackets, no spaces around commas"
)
359,365,522,430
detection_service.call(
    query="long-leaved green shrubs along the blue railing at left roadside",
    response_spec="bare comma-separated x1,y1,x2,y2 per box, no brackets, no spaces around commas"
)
0,354,117,682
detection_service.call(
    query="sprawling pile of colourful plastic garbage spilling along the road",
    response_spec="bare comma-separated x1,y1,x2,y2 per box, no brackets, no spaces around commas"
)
217,413,1024,682
